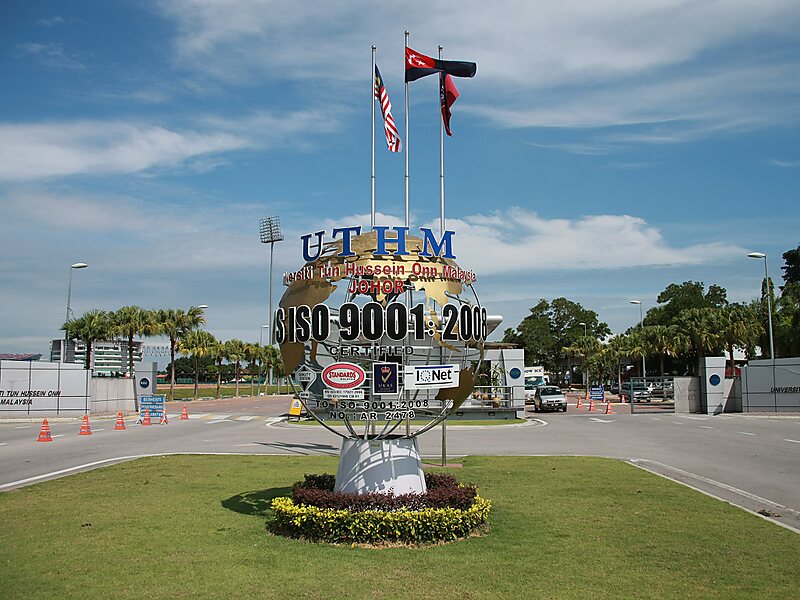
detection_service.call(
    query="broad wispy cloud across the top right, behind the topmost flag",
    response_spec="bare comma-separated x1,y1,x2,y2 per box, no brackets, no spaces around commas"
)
152,0,800,139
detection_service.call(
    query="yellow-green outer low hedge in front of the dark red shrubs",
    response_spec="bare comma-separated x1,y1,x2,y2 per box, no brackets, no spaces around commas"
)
272,496,492,544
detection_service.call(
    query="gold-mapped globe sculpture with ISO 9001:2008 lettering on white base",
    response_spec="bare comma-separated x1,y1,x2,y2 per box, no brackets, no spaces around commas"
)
274,230,487,494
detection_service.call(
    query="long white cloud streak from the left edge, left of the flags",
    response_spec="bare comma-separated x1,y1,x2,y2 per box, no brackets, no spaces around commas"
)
0,107,342,181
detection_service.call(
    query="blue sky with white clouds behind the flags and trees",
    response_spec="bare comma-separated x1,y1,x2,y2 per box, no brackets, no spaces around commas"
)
0,0,800,352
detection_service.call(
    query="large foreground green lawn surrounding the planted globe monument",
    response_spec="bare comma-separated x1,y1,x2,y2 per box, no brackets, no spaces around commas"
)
0,456,800,600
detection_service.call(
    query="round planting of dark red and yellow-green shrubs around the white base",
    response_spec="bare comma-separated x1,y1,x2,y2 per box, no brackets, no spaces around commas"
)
272,473,491,544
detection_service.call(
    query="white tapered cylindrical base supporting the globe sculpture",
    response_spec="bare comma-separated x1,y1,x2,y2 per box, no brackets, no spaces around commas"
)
335,438,427,495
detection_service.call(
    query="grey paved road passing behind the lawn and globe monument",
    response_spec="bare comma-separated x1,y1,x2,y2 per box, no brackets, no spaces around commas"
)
0,398,800,529
